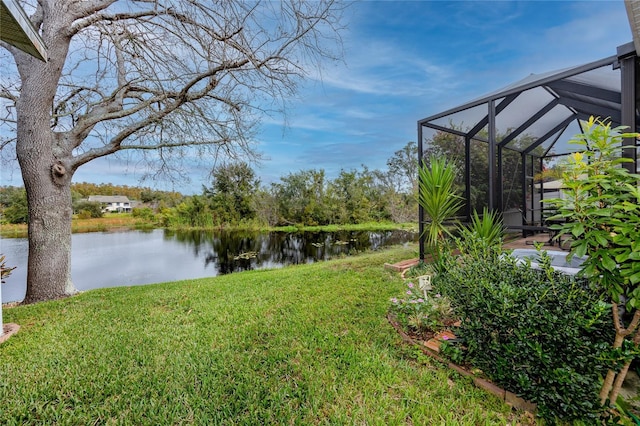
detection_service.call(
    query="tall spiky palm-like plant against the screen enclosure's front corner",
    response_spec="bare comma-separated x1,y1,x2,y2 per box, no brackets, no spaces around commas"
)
418,156,464,251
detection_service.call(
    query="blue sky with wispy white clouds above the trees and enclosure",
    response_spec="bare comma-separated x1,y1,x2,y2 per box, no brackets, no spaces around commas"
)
2,0,632,194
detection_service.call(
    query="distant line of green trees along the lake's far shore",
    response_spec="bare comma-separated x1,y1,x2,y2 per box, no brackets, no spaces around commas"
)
0,142,417,228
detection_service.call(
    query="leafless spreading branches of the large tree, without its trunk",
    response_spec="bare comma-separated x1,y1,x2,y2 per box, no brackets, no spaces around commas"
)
13,0,341,176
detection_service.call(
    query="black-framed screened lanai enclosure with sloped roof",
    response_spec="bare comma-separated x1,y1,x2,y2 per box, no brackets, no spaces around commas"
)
418,43,640,259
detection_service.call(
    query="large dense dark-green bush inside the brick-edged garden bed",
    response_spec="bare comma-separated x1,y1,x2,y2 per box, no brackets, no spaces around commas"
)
433,246,613,423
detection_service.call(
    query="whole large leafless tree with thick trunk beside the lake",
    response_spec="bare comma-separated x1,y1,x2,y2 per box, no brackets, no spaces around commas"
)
0,0,342,303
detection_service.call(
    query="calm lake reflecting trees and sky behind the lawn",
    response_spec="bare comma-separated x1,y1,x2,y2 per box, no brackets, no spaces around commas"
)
0,229,418,303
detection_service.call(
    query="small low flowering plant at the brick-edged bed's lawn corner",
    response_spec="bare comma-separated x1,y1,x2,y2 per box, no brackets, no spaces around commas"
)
391,282,455,337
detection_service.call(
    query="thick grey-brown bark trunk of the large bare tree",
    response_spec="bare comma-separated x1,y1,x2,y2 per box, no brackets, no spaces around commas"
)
14,7,75,303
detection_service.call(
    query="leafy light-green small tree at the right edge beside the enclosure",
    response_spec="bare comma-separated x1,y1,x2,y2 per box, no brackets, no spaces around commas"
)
548,117,640,405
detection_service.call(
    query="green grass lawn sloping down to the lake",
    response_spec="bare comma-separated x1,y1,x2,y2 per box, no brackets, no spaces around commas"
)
0,247,518,425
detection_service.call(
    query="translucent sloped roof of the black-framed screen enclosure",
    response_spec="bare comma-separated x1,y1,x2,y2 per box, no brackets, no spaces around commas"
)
418,43,640,155
